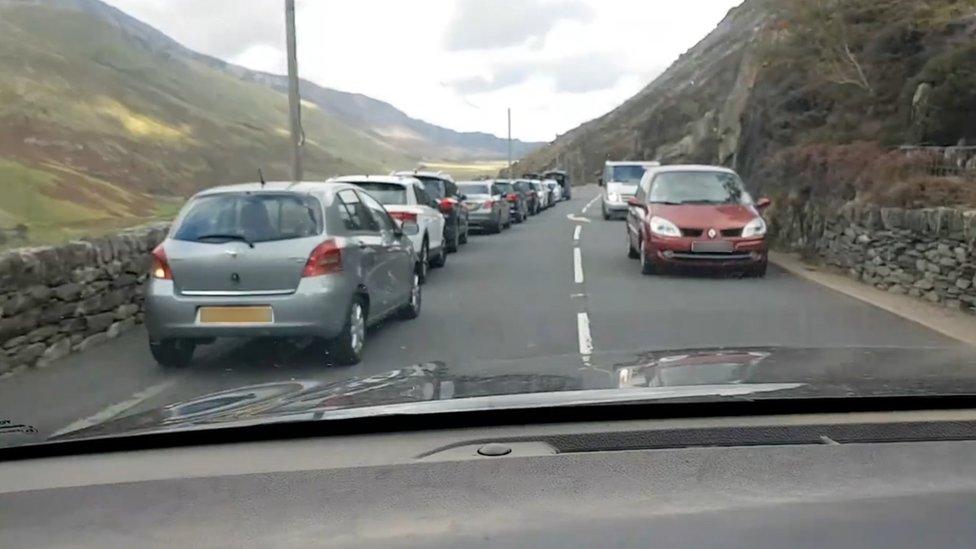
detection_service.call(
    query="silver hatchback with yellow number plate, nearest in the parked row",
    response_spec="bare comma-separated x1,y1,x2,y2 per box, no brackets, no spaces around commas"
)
146,183,421,367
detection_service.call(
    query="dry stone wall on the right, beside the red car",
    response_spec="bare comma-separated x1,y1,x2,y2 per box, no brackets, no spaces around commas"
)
768,203,976,312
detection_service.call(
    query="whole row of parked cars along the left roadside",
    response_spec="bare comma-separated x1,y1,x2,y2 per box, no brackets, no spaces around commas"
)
146,171,569,367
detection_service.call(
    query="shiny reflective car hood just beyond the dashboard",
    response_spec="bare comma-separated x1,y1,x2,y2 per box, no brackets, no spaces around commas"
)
52,347,976,440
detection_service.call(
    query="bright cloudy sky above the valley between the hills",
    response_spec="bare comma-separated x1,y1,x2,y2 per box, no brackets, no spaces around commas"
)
107,0,741,141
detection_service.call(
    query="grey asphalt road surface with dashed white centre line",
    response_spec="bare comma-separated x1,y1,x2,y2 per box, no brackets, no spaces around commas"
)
0,186,957,445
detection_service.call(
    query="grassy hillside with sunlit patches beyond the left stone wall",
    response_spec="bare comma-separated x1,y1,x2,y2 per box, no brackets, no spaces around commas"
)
0,3,416,246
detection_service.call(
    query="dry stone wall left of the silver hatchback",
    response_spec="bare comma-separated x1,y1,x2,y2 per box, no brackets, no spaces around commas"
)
0,224,167,374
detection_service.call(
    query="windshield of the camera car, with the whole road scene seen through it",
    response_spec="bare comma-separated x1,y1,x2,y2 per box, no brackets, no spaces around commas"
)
0,0,976,458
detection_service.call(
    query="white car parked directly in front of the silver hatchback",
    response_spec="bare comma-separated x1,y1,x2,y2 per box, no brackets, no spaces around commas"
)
329,175,447,282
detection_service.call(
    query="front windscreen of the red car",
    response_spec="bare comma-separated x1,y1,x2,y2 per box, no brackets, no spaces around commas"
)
650,172,752,204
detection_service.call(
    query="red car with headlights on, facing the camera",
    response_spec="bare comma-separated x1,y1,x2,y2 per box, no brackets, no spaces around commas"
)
627,166,770,277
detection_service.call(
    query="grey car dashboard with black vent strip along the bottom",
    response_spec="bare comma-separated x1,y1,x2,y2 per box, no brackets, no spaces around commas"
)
0,410,976,548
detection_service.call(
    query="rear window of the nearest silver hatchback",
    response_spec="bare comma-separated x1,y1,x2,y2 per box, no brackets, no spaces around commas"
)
173,193,322,243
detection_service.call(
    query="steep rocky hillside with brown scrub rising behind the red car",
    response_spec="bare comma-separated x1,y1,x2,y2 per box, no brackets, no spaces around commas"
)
517,0,976,205
